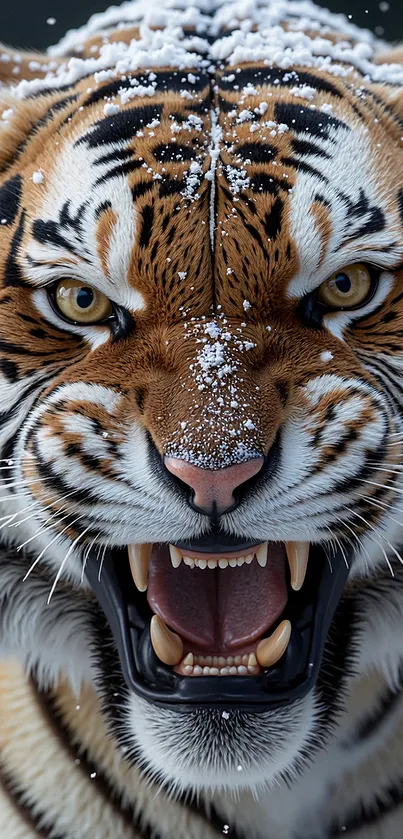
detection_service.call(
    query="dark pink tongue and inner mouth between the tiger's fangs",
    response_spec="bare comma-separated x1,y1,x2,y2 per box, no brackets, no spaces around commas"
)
147,543,287,653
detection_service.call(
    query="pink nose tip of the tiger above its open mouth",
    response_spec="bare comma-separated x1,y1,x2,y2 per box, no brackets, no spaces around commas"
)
164,457,264,515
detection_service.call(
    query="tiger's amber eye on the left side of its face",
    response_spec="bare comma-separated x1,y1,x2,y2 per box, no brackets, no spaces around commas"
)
54,280,112,323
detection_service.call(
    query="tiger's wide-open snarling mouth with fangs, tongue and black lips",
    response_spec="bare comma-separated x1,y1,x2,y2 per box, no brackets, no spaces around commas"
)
86,530,354,710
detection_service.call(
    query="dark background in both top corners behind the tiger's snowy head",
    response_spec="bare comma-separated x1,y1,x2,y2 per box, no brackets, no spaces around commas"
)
0,0,403,49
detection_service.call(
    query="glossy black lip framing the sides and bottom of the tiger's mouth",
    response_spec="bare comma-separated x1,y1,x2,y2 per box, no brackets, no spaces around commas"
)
85,539,351,712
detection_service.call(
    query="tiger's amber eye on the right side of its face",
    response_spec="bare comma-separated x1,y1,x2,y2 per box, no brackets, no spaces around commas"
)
317,262,372,309
